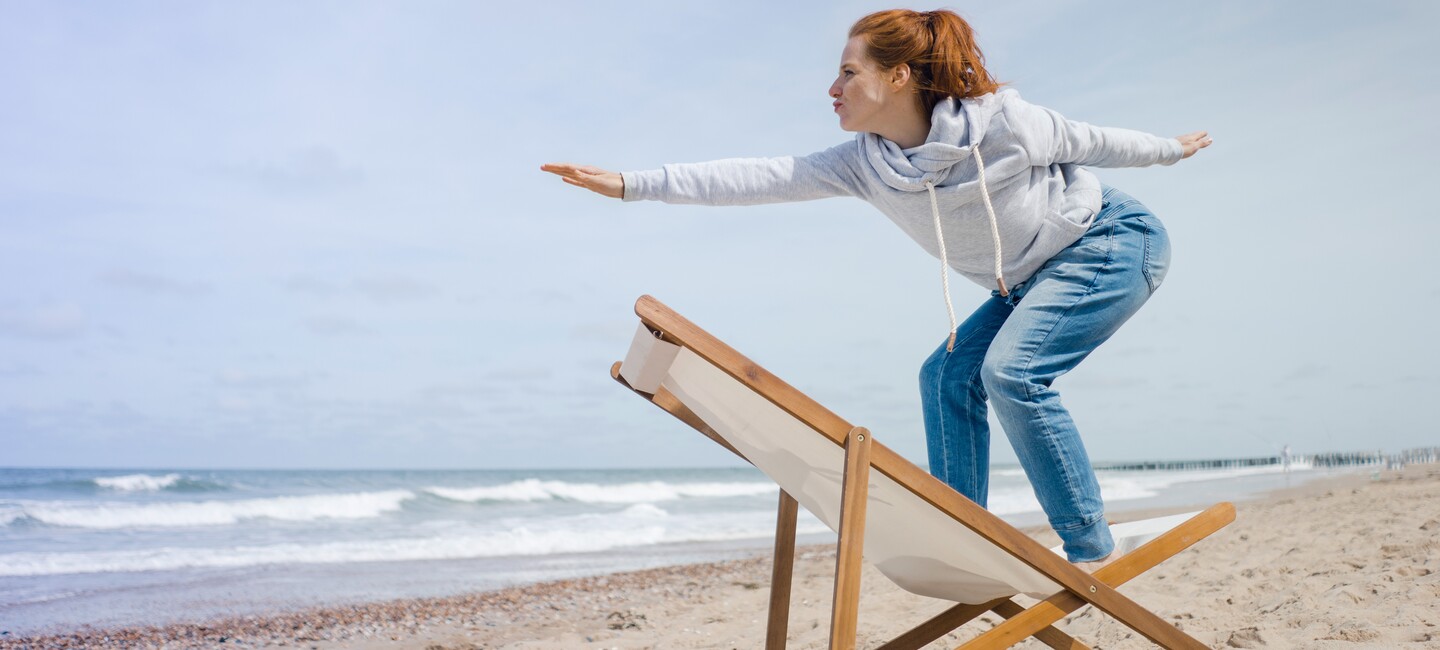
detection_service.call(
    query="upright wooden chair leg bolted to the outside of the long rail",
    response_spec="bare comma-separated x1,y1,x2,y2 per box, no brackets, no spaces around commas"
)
829,427,871,650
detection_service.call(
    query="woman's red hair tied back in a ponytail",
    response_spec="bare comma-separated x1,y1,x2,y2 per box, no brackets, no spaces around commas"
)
850,9,1001,115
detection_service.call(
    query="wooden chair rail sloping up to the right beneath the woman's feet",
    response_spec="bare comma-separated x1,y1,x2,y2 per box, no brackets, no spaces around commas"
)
960,503,1236,650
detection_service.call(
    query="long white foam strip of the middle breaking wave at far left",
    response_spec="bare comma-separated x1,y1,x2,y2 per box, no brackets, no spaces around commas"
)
22,490,415,529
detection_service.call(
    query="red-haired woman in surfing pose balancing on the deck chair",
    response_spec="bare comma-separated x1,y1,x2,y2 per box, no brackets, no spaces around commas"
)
541,10,1211,571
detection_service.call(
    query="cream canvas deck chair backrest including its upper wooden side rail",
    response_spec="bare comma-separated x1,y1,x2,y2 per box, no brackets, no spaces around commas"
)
621,315,1060,602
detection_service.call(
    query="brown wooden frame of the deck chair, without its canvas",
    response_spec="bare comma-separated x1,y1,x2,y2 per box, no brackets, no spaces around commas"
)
611,295,1236,650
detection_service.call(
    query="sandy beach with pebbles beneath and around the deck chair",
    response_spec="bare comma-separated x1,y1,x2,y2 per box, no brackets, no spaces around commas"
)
0,464,1440,650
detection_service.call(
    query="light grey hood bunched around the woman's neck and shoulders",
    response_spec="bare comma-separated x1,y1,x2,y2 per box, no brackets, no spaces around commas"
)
855,91,1014,192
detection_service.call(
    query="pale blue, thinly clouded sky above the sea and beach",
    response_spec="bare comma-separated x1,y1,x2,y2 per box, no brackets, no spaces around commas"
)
0,0,1440,468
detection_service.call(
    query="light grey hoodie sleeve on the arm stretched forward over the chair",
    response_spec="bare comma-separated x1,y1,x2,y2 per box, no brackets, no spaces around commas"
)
621,141,860,206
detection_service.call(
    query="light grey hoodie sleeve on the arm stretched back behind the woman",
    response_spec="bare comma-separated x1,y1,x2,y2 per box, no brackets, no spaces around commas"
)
1004,97,1185,167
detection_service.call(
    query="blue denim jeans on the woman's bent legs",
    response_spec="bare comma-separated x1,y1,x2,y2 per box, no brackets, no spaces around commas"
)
920,187,1169,562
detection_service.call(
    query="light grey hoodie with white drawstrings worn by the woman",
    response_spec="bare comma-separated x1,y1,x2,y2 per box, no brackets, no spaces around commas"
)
622,89,1184,288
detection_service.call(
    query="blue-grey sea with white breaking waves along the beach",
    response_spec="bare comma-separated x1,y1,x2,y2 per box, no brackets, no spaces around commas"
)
0,466,1332,638
